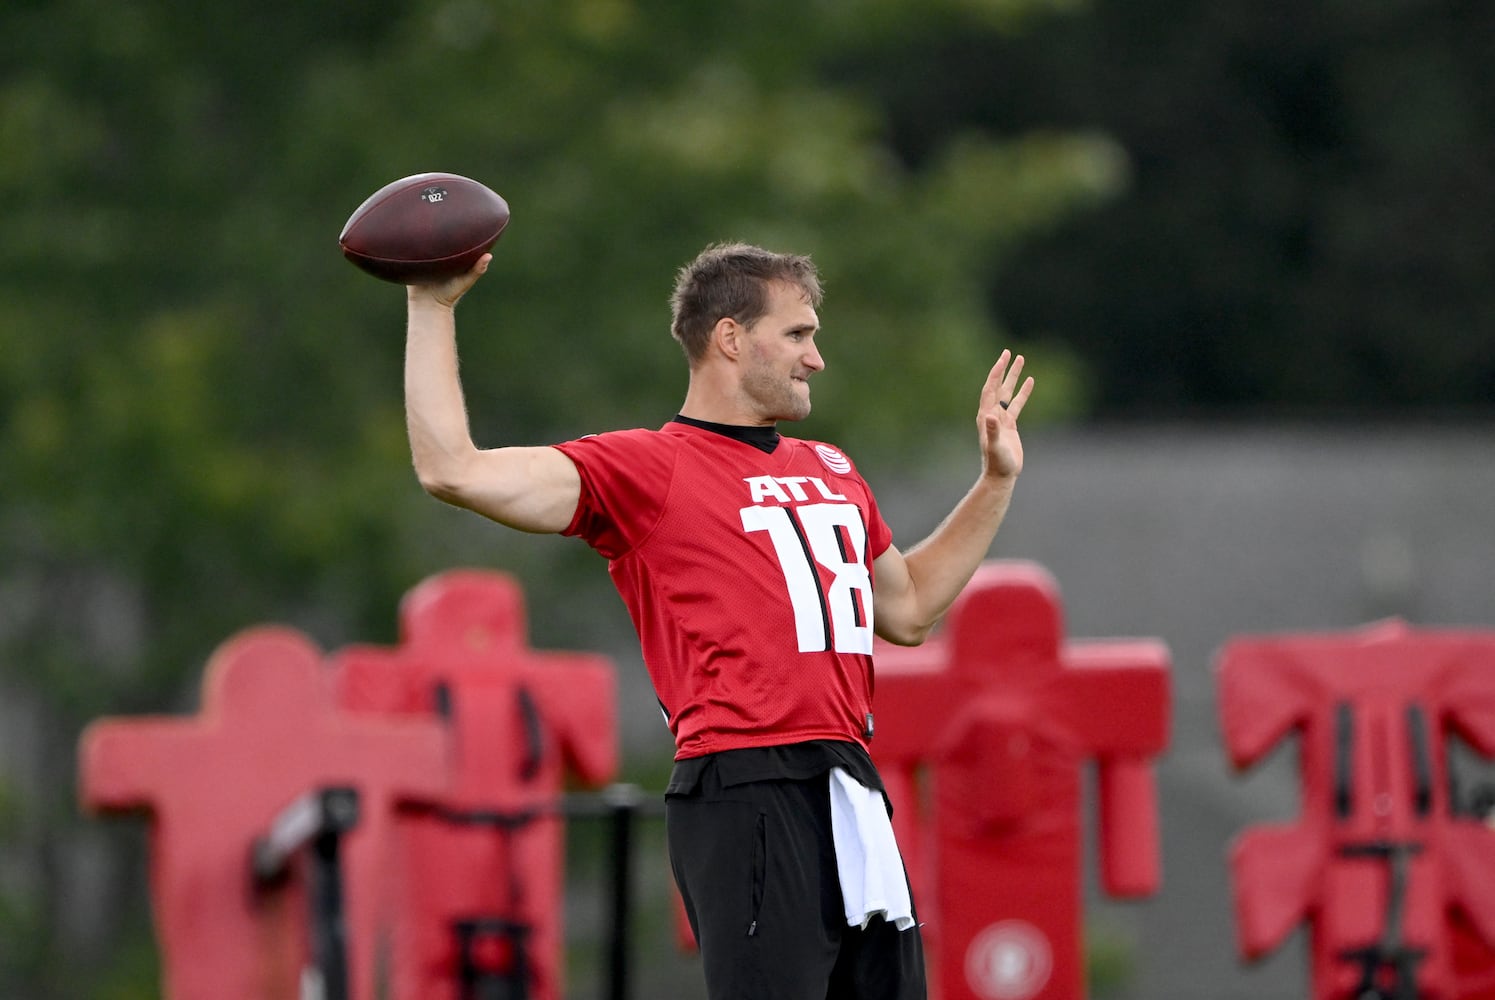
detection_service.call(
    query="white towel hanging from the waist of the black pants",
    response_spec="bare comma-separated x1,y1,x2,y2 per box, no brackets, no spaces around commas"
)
831,767,913,931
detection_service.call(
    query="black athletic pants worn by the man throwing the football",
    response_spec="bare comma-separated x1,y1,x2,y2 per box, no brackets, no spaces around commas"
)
665,768,925,1000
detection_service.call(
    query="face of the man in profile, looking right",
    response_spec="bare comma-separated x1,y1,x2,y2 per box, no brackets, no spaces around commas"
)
742,281,825,423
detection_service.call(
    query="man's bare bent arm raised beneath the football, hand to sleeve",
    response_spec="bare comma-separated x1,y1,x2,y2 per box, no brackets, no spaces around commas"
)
405,256,582,532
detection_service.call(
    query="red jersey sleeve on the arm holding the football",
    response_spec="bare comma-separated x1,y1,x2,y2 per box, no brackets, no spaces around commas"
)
555,430,674,559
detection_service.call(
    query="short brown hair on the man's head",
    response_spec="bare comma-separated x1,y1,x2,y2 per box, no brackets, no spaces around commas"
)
670,244,821,365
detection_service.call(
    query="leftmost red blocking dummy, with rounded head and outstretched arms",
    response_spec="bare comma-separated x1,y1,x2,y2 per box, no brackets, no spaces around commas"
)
79,628,446,1000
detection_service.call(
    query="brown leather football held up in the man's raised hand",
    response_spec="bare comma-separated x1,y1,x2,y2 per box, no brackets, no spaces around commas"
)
338,173,508,284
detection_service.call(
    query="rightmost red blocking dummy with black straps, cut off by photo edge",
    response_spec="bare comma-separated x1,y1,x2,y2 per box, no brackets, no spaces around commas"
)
1218,620,1495,1000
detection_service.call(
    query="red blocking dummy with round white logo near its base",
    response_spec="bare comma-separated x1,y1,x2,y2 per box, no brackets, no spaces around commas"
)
872,562,1169,1000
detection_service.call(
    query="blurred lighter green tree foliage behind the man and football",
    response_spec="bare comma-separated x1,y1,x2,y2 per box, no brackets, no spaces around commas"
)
0,0,1126,999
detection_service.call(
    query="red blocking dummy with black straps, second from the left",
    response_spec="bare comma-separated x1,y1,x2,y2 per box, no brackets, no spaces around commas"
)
335,570,617,1000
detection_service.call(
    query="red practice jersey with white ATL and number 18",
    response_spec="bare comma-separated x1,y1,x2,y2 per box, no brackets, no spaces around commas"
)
558,422,893,759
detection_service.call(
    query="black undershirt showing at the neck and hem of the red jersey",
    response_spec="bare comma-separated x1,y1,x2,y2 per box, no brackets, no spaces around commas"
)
664,414,882,795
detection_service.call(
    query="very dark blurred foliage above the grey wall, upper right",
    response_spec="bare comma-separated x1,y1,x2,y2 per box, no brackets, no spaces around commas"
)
854,0,1495,420
